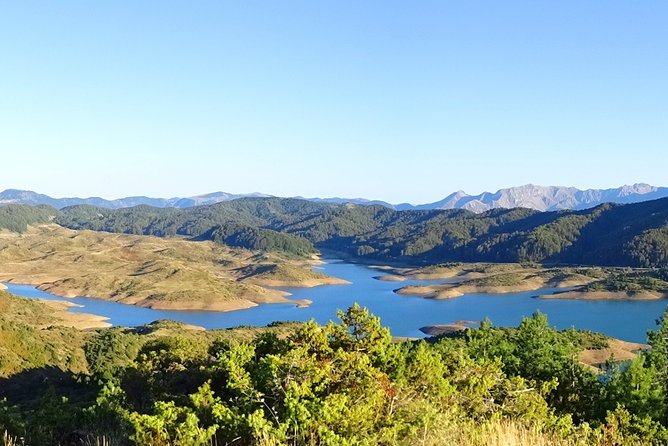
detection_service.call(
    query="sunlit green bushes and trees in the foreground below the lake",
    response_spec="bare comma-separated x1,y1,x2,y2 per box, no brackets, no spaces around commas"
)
0,293,668,446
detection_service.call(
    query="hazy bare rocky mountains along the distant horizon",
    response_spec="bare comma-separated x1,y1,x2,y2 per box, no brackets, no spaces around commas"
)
0,183,668,213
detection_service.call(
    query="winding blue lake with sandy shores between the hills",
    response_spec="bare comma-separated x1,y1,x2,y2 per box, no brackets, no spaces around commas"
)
6,260,668,342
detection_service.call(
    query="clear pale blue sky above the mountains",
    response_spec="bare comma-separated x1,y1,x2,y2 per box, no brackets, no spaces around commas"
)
0,0,668,203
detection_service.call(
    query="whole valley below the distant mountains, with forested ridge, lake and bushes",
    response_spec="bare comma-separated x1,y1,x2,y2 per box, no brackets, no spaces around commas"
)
0,198,668,446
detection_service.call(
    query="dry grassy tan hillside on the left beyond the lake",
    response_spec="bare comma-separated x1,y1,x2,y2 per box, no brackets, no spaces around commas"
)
0,225,342,310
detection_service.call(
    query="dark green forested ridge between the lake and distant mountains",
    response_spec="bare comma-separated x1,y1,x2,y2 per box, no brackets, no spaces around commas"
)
52,198,668,267
